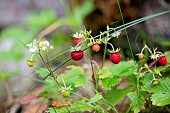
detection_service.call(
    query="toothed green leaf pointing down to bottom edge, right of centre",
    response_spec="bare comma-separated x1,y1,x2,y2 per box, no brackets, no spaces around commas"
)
128,91,147,113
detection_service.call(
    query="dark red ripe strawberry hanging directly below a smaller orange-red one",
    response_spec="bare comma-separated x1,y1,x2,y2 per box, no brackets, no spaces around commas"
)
71,50,84,61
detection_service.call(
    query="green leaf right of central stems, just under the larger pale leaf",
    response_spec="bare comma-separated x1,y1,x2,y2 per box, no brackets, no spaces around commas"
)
101,77,122,90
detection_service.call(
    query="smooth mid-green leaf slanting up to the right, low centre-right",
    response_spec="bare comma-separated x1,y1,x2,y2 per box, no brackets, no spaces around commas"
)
106,86,133,105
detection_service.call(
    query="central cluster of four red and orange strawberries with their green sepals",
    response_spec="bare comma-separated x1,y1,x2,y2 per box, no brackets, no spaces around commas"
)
71,31,122,64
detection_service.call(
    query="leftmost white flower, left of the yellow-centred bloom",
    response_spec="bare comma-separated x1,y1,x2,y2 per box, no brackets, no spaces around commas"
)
26,39,38,53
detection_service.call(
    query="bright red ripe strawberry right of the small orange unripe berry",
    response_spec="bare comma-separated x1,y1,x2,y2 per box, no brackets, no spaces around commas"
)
109,52,122,64
